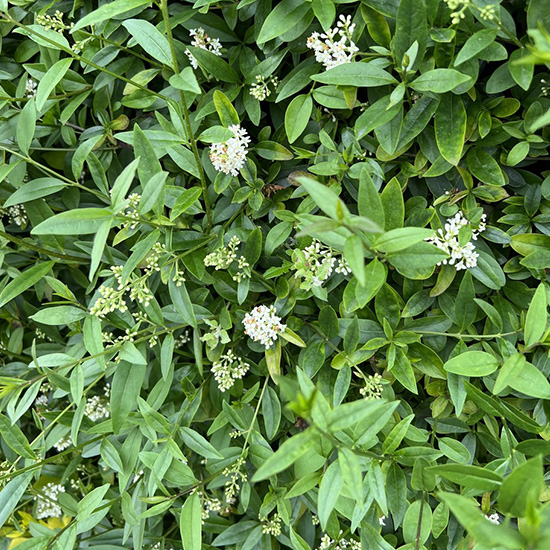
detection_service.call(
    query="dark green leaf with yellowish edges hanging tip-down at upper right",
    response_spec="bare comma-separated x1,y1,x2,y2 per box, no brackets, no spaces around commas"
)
435,93,466,166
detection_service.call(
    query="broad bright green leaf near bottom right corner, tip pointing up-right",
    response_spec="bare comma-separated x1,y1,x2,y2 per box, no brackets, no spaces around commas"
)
497,455,544,518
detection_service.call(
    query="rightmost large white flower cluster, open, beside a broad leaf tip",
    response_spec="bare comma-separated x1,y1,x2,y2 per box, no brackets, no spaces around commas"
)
426,212,486,271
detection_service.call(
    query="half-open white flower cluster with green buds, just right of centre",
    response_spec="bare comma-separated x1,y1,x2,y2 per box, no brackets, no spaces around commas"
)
293,239,351,290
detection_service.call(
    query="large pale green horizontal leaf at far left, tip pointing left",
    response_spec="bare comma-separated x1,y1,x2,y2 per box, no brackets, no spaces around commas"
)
31,208,114,235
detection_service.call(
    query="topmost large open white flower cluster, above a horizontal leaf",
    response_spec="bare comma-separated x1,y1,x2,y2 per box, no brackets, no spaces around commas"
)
306,15,359,69
